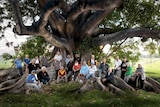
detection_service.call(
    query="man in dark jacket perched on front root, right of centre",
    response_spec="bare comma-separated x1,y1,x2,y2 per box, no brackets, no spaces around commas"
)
102,68,114,86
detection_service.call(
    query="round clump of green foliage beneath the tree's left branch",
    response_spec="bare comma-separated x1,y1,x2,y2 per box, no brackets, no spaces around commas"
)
20,36,47,58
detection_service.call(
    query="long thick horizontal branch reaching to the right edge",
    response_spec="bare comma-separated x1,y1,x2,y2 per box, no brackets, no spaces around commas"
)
93,28,160,45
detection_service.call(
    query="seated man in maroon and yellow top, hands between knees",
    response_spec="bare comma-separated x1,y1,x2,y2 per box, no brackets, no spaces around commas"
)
57,66,67,83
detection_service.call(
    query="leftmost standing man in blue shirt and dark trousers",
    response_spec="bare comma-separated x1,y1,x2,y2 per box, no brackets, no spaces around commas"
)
14,55,23,76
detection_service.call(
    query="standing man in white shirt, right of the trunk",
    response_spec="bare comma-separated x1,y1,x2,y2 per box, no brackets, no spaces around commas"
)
114,56,122,77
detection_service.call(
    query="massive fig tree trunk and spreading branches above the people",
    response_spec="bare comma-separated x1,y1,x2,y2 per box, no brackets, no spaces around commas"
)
9,0,160,59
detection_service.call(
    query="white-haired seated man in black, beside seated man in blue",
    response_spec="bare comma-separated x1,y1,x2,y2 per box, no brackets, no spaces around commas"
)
37,66,50,84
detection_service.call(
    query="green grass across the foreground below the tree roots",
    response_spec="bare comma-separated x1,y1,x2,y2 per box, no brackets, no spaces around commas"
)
0,83,160,107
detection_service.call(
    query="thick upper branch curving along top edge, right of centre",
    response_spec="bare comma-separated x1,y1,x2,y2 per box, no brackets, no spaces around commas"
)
68,0,123,20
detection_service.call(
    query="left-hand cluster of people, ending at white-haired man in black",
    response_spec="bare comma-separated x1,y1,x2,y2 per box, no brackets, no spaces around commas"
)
14,54,50,91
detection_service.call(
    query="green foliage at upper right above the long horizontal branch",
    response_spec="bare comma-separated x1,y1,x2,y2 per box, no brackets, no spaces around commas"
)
102,0,160,31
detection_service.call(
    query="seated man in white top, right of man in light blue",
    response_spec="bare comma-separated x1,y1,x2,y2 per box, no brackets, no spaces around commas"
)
86,63,97,79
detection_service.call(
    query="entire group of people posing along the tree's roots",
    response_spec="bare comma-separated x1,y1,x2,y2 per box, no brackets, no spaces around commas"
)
15,51,145,89
